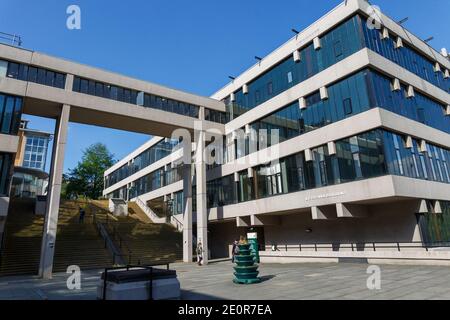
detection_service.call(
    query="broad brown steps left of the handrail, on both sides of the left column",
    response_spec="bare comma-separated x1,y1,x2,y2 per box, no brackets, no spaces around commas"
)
0,200,112,276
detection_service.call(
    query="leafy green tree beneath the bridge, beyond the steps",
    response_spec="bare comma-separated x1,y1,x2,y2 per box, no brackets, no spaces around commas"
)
63,143,115,199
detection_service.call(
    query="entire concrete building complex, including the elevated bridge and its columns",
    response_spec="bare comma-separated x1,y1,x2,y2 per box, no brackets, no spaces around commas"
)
0,0,450,277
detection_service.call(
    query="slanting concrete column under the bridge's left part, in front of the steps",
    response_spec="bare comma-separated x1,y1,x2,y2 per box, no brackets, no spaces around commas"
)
39,105,70,279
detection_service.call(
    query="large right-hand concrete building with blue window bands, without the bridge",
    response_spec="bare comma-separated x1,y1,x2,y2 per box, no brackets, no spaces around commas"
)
104,1,450,261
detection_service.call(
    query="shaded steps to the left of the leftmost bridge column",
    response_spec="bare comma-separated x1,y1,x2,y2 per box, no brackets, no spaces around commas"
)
0,199,44,276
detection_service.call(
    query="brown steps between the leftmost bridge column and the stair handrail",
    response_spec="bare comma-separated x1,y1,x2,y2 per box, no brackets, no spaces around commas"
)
53,201,112,272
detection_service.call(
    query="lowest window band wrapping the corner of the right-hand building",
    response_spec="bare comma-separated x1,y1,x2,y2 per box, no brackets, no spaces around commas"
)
207,129,450,207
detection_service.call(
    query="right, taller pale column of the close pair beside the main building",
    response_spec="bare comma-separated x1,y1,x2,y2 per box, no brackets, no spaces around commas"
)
195,130,209,264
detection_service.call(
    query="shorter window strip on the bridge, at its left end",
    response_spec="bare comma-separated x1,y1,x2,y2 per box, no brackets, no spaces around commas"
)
2,61,66,89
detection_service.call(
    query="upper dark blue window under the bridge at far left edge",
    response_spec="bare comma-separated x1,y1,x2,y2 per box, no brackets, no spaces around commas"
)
0,93,22,135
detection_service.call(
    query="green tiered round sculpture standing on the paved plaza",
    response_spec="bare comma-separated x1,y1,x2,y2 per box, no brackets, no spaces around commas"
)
233,244,261,284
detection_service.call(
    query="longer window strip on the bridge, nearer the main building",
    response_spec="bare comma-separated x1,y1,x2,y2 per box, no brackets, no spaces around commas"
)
73,77,199,118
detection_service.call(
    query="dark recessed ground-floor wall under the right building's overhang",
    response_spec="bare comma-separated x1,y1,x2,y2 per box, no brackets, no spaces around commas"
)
264,201,420,245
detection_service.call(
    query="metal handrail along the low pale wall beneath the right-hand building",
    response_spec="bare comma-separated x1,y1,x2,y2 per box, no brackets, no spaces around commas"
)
264,241,450,252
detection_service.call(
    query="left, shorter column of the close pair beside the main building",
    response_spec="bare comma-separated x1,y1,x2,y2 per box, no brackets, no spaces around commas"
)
183,141,192,262
